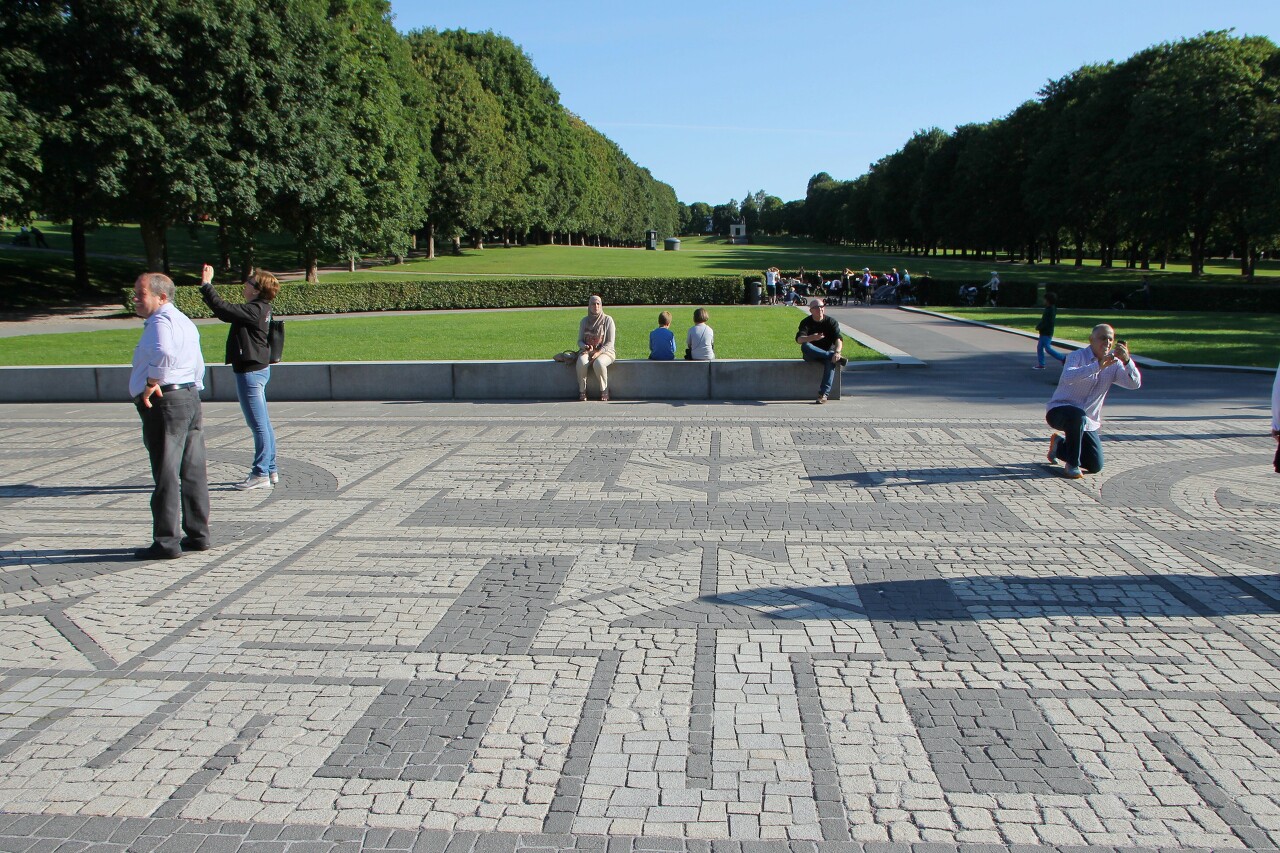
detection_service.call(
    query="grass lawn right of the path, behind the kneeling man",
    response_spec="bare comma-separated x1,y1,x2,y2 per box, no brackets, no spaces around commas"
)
931,307,1280,368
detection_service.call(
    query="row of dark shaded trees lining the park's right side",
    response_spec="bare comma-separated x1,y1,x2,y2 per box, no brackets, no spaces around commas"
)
682,32,1280,275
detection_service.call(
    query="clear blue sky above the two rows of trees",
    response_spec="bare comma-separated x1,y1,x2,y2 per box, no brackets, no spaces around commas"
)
392,0,1280,204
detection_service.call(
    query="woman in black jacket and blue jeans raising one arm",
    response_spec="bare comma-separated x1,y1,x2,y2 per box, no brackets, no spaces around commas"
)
200,264,280,489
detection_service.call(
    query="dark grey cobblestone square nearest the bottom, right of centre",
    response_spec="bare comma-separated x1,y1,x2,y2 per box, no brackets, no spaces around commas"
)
902,688,1094,794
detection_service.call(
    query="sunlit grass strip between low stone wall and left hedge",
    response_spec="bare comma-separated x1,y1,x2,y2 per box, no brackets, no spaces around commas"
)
0,306,882,365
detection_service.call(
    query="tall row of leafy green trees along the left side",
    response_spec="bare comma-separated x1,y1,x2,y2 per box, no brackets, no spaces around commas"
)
0,0,680,283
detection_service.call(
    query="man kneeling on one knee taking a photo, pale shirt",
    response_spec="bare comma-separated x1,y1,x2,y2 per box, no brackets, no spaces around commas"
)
1044,323,1142,480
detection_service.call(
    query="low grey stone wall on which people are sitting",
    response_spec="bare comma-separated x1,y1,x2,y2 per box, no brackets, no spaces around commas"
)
0,360,893,402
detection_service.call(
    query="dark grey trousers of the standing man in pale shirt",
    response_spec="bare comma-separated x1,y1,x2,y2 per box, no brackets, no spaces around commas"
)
136,388,209,555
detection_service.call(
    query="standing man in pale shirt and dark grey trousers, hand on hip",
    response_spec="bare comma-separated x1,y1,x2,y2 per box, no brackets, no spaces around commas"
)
129,273,210,560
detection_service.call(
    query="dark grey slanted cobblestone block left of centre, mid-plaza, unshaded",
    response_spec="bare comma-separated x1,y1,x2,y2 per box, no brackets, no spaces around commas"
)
420,557,573,654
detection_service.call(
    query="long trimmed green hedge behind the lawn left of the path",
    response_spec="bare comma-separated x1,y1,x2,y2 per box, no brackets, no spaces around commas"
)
123,275,744,318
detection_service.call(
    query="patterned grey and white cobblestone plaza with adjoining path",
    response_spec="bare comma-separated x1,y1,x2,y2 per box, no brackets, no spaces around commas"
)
0,309,1280,853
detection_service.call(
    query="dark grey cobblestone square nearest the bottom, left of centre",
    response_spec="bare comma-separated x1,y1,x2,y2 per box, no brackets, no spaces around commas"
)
316,680,509,783
